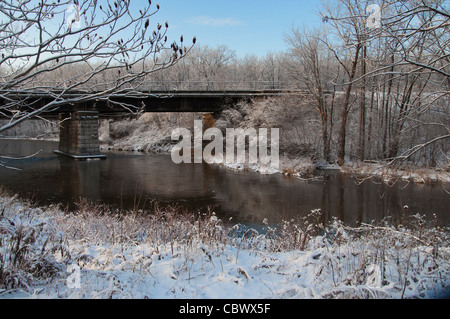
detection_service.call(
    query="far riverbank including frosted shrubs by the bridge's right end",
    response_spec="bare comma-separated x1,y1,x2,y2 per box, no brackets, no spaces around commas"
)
94,109,450,184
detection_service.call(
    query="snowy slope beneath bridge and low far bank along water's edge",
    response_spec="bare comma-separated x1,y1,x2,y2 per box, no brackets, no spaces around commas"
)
99,113,450,184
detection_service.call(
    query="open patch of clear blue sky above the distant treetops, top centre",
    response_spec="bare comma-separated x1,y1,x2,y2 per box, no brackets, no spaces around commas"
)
136,0,321,57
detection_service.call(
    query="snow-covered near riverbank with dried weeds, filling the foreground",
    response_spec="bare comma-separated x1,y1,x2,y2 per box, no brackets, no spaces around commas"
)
0,192,450,299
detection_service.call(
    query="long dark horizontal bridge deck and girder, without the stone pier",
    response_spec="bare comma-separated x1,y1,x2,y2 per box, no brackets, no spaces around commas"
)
4,90,301,119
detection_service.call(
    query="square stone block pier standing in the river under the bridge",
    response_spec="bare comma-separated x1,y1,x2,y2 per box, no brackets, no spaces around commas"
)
55,111,106,160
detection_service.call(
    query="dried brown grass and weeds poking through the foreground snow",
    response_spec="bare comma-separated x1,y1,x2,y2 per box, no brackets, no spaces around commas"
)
0,189,450,298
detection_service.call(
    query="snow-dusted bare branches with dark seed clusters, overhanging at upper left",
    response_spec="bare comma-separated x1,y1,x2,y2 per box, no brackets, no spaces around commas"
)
0,0,195,132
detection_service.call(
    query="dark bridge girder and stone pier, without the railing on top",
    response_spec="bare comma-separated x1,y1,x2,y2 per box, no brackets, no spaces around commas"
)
0,91,288,160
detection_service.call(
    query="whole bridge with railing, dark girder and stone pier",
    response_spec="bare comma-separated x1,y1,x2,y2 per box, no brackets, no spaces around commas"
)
0,82,305,160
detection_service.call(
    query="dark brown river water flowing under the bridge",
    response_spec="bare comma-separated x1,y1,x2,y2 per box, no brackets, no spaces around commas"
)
0,140,450,226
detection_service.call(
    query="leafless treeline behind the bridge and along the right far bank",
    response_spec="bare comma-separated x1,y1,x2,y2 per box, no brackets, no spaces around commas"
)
152,0,450,167
